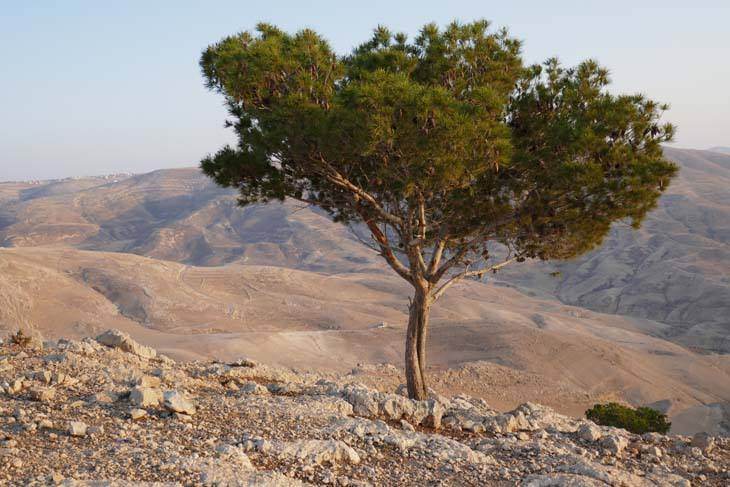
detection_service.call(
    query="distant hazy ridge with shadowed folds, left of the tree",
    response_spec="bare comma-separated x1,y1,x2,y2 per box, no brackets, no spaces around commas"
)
0,168,375,270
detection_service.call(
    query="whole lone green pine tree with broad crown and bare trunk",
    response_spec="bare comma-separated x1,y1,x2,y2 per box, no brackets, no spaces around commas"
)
200,20,676,399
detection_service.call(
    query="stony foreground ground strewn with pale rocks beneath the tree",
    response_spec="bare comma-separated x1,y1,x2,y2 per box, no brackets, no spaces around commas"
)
0,331,730,487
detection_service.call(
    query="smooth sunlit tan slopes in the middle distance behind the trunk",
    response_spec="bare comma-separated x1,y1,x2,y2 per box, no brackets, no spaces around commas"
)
0,248,730,430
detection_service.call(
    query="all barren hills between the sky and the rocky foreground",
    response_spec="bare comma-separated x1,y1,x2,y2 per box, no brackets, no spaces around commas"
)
0,149,730,440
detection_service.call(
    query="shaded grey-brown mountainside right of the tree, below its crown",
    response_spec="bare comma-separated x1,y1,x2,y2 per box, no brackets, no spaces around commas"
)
498,149,730,352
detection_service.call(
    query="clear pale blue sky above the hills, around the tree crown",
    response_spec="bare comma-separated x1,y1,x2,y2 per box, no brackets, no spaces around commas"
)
0,0,730,181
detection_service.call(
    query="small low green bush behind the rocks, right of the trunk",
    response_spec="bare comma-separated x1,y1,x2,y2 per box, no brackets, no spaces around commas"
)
586,402,672,435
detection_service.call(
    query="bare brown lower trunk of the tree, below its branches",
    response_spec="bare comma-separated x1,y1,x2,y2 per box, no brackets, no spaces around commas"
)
406,289,431,400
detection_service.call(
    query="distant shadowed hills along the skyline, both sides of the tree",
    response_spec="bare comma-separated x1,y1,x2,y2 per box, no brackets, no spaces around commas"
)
0,148,730,352
